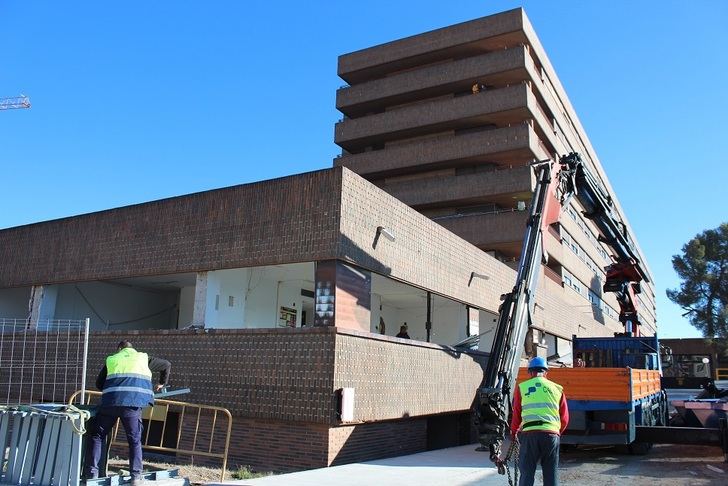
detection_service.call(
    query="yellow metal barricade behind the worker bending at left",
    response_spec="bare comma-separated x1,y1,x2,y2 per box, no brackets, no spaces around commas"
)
69,390,233,481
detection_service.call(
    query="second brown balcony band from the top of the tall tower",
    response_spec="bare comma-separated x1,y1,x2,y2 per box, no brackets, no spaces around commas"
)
336,46,530,118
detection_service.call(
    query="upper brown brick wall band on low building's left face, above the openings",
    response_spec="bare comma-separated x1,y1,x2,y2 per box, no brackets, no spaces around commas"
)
0,170,341,288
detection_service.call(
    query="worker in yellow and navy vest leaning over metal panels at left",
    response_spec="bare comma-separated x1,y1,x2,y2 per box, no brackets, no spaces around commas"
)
86,341,171,485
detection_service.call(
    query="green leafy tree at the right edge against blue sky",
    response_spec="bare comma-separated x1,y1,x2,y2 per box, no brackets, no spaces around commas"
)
667,223,728,338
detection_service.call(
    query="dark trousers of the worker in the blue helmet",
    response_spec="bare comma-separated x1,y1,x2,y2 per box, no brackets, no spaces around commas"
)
518,432,560,486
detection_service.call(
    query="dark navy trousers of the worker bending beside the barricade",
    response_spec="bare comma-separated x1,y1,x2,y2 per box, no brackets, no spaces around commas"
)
86,407,143,478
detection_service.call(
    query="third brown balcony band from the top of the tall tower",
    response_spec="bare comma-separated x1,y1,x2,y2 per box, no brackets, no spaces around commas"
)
334,83,537,152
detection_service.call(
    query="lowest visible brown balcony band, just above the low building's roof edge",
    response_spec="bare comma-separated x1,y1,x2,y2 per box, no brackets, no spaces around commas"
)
434,211,528,250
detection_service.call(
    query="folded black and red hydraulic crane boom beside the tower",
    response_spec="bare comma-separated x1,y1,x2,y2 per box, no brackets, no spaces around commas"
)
478,153,647,474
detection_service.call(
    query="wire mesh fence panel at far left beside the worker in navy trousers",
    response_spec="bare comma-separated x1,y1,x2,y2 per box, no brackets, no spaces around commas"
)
0,318,89,405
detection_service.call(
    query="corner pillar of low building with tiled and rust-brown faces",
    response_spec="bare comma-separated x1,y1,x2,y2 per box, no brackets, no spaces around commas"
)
314,260,372,332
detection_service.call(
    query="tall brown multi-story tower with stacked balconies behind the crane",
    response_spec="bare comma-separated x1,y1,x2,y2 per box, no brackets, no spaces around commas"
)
334,9,656,342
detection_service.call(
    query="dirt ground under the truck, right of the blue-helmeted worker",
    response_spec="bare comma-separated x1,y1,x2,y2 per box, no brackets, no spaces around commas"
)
556,445,728,486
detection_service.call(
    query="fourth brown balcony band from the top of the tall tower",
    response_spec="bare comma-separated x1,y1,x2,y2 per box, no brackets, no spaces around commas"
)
334,123,549,180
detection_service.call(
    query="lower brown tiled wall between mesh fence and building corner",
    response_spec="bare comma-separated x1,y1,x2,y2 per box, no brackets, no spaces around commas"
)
88,328,336,424
